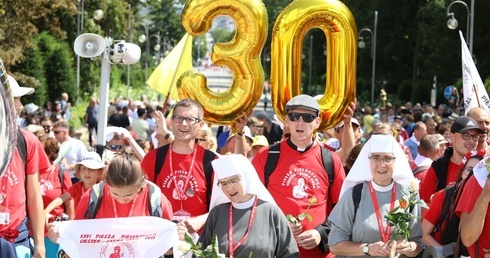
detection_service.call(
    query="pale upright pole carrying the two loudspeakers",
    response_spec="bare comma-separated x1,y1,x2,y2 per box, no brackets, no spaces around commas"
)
96,38,112,157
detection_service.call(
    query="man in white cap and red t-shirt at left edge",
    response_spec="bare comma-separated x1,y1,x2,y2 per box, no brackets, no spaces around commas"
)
0,75,50,257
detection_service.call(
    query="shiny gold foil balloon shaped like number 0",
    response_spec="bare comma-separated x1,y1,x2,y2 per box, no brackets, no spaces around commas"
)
271,0,357,130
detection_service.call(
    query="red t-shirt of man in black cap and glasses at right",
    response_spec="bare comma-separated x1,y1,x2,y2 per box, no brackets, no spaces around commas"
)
420,161,462,204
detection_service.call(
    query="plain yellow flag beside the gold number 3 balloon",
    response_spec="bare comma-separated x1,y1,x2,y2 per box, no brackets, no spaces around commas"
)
146,33,192,100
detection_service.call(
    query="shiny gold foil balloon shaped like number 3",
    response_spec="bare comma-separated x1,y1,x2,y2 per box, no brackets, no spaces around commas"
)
177,0,268,125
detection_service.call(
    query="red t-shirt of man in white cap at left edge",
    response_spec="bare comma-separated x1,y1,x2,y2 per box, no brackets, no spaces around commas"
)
0,129,49,232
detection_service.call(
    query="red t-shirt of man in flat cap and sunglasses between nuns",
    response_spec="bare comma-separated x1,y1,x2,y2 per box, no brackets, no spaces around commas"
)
252,141,345,257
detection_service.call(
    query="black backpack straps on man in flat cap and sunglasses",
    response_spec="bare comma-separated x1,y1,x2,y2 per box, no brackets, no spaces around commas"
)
264,142,335,190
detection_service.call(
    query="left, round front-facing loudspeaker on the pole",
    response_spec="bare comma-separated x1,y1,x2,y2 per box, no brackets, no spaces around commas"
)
73,33,105,58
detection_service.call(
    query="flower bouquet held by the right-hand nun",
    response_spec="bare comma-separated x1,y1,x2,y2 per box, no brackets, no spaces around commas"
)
386,179,428,257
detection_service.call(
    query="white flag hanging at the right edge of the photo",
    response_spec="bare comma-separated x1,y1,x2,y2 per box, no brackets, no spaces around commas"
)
459,31,490,115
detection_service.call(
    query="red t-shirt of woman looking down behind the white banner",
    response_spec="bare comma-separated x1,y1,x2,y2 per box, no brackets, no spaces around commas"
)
75,184,173,220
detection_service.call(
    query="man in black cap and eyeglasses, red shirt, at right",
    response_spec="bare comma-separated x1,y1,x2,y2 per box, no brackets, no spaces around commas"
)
420,116,483,203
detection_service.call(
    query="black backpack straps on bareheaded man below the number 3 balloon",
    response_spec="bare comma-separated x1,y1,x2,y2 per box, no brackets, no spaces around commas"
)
154,144,216,210
